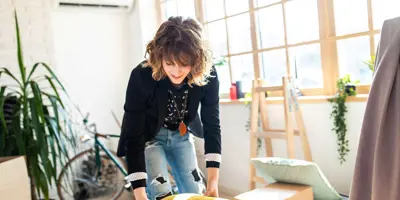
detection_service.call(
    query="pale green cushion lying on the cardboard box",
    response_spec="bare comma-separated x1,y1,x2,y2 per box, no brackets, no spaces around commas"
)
251,157,341,200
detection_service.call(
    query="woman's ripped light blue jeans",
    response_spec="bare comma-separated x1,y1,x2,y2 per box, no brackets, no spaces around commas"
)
145,128,203,200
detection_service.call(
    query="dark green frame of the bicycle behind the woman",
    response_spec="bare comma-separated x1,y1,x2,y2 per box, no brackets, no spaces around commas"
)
94,135,128,176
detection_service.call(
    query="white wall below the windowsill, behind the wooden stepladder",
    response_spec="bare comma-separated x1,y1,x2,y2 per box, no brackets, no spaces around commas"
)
196,102,366,194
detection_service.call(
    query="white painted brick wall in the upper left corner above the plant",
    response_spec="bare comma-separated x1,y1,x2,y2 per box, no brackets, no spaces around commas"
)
0,0,54,75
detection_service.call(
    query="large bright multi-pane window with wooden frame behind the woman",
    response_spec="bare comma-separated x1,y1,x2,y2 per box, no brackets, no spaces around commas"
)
160,0,400,96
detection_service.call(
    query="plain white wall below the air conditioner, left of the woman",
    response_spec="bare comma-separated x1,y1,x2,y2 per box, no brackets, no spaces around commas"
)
52,8,131,152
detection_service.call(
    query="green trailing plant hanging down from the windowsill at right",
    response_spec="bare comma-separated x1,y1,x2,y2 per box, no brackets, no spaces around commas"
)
329,74,358,164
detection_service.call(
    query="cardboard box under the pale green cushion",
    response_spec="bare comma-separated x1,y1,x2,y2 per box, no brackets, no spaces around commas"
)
234,183,314,200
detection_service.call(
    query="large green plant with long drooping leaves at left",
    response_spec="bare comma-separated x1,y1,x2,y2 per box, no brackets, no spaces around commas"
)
0,11,76,199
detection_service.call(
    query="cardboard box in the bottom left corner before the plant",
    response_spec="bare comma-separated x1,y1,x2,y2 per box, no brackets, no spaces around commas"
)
0,156,31,200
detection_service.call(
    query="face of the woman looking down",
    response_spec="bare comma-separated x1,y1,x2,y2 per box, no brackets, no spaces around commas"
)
162,59,192,84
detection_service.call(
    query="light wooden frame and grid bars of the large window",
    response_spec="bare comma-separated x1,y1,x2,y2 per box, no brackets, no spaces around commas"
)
155,0,381,98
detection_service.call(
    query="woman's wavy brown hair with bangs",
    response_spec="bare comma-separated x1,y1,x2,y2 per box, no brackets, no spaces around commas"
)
145,16,211,86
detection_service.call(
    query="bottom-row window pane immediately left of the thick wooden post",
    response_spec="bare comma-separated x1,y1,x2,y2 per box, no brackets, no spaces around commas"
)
289,44,324,88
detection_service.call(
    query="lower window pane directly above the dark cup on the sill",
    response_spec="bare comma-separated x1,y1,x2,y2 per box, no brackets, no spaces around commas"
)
230,53,254,92
